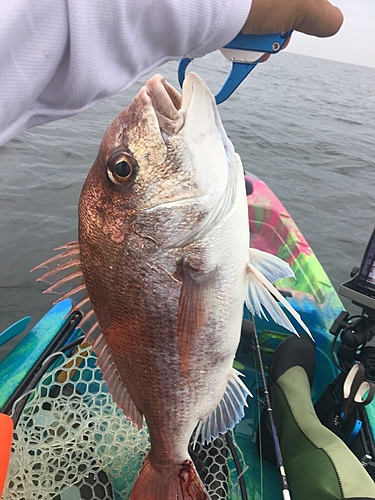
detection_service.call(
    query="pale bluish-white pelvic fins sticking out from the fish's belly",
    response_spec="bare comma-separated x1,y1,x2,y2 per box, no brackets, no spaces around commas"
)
246,249,312,338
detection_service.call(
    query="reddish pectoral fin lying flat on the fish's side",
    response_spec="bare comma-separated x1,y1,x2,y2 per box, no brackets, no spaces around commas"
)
175,259,217,373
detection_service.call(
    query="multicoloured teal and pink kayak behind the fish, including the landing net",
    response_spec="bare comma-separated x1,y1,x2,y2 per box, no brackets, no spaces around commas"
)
0,173,375,500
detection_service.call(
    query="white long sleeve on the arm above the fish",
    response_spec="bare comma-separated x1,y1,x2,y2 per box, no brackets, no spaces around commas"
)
0,0,251,145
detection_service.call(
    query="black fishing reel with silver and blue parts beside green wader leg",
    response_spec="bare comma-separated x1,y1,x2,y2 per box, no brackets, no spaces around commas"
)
326,306,375,474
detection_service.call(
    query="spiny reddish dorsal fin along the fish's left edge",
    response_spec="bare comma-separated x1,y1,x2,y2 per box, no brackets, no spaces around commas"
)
31,241,143,429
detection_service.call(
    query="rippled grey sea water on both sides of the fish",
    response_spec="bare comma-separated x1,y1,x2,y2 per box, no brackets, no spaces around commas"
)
0,49,375,348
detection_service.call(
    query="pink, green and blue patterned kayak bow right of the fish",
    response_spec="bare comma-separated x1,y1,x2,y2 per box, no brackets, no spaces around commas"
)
245,174,344,396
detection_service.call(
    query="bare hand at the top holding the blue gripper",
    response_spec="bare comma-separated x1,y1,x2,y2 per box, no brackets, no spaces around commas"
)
242,0,344,37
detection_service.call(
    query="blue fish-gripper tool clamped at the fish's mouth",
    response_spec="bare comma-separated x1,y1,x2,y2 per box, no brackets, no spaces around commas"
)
178,31,292,104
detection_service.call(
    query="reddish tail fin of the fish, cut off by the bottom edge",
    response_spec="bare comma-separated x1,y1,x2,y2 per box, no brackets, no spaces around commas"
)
130,455,210,500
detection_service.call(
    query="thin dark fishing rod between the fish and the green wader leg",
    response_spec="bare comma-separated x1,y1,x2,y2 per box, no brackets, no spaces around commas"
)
242,316,291,500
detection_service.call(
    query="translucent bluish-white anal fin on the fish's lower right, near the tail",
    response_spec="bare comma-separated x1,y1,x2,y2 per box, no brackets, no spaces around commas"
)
194,368,252,446
